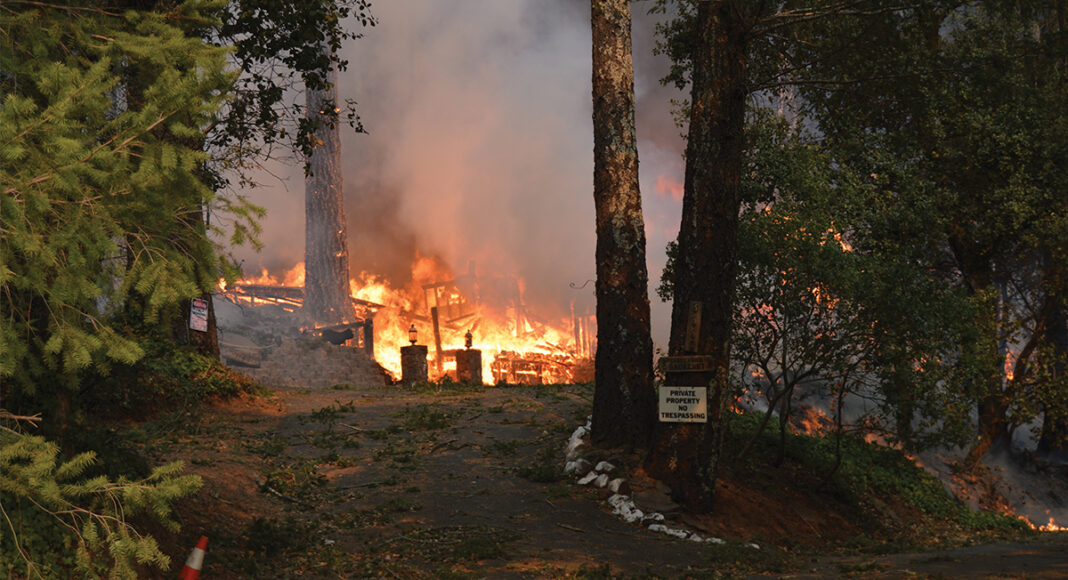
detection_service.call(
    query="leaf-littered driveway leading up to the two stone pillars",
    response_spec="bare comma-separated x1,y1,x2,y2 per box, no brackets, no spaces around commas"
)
150,386,1068,578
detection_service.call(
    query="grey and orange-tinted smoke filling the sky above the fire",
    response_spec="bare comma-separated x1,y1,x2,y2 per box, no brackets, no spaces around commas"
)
229,0,684,345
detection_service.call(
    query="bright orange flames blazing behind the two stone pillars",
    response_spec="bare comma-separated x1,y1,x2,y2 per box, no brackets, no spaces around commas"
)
220,256,591,382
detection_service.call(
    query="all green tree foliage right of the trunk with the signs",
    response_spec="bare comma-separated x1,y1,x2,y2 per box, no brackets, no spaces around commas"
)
655,0,1068,448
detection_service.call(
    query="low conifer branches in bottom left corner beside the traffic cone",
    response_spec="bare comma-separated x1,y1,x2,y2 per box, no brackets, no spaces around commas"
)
0,432,201,578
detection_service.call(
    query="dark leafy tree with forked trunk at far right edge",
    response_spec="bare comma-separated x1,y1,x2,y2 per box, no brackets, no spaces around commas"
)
796,2,1068,464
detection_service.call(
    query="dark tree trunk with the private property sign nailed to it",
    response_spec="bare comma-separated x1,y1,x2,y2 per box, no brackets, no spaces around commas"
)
646,0,749,512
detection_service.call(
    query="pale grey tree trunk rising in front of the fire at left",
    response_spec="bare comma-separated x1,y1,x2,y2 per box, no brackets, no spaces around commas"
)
302,59,354,324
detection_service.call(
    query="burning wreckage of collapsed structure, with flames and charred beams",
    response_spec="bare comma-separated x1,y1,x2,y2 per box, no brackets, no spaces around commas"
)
219,258,596,385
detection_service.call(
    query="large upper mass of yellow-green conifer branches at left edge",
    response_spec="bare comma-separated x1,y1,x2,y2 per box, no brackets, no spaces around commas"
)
0,0,248,422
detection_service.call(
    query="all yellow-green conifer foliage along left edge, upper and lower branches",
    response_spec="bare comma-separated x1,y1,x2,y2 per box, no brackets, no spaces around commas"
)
0,0,256,578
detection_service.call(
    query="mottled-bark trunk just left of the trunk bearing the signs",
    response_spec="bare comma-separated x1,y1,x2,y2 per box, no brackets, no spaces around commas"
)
591,0,656,449
